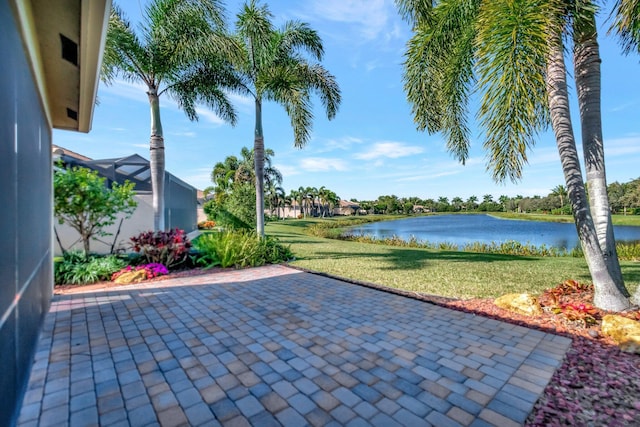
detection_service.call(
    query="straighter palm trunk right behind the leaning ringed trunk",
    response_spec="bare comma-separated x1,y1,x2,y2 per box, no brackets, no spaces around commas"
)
574,15,629,296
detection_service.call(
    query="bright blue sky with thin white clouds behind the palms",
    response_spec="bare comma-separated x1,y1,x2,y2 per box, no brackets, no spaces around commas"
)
54,0,640,200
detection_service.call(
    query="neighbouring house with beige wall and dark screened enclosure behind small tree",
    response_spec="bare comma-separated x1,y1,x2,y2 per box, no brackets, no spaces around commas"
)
53,146,197,255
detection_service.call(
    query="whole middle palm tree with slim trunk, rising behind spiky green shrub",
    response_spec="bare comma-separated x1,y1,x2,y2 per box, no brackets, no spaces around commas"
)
231,0,340,236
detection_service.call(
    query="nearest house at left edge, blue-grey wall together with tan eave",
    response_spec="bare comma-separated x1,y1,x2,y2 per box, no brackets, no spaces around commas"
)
0,0,111,426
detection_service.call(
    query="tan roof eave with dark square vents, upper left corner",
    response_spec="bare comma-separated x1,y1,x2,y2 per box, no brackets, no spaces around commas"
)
10,0,111,132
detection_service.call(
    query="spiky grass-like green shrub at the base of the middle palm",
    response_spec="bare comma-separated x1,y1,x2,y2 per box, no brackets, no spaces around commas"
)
194,230,292,268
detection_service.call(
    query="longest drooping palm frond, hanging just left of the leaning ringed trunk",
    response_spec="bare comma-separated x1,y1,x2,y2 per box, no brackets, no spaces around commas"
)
477,0,551,182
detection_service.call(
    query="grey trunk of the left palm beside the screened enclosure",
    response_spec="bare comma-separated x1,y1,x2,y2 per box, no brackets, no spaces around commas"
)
147,87,165,231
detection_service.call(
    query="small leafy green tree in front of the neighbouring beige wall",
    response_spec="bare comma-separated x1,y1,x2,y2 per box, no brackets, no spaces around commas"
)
53,167,137,256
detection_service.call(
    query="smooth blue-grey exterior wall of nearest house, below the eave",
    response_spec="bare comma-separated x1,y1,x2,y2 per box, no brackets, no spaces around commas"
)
0,1,53,426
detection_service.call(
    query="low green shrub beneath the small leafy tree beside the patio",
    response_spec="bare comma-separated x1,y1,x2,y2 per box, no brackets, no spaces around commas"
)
54,251,127,285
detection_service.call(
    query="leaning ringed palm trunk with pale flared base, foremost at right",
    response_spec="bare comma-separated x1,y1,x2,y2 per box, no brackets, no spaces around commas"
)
547,37,629,311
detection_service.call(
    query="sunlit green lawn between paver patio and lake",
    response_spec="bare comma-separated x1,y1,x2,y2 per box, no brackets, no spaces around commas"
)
266,219,640,298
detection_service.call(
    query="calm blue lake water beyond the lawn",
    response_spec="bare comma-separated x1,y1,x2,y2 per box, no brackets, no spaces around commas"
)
350,215,640,250
